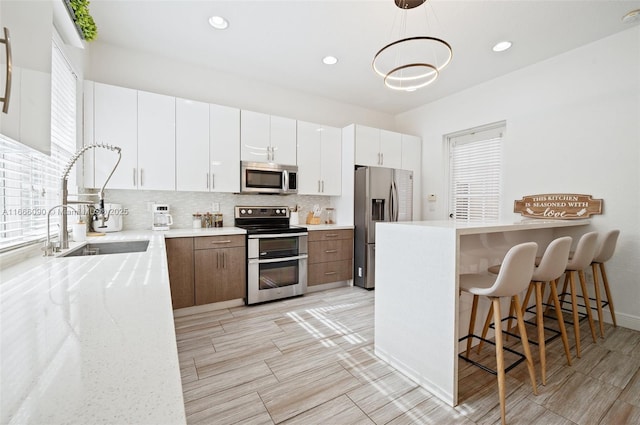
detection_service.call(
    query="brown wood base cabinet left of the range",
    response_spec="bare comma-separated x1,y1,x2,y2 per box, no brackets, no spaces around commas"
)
165,235,247,309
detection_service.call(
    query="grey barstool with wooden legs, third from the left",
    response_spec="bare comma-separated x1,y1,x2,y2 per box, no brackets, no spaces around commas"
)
560,232,598,358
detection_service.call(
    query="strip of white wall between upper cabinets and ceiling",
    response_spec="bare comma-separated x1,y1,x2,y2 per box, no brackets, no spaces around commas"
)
85,41,395,129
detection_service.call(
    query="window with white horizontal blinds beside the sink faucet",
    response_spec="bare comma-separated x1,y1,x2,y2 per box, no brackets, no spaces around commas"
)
0,41,77,252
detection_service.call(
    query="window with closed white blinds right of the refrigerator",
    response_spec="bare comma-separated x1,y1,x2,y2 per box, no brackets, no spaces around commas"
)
446,123,505,221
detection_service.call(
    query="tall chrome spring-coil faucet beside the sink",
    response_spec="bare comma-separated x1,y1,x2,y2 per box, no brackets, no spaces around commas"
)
56,143,122,255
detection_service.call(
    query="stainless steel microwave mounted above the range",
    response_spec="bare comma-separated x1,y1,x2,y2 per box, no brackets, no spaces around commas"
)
240,161,298,195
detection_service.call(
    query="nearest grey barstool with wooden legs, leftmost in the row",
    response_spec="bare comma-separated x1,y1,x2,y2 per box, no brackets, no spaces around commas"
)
460,242,538,424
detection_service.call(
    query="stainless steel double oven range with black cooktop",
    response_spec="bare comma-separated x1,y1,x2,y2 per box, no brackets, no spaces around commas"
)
234,206,309,304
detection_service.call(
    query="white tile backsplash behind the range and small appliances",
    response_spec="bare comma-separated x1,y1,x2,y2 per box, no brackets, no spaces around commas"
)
105,189,331,230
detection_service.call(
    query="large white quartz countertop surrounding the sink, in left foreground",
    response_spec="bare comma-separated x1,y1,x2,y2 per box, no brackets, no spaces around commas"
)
0,231,186,425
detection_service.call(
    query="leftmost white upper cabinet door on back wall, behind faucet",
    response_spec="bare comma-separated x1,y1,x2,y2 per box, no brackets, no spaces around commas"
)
91,83,138,189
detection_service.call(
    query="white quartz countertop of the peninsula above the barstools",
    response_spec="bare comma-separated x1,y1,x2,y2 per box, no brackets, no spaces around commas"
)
377,219,590,235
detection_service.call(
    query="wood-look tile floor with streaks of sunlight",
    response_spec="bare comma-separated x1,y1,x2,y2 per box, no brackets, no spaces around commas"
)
175,287,640,425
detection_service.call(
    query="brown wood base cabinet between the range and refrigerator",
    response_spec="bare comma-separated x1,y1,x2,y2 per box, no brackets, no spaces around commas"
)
307,229,353,286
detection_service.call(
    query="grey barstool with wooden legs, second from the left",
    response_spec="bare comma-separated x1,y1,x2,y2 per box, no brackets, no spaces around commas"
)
482,236,572,385
